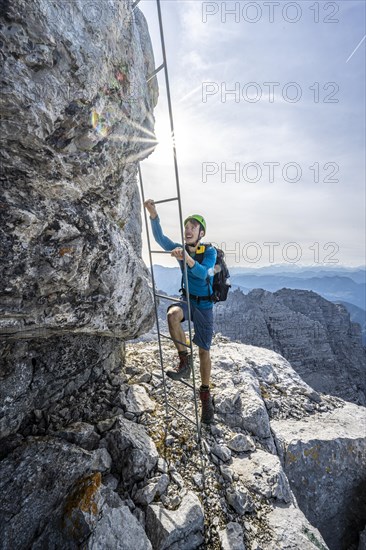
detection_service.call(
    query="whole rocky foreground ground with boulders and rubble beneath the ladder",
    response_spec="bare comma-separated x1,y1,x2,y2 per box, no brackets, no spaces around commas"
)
0,335,366,550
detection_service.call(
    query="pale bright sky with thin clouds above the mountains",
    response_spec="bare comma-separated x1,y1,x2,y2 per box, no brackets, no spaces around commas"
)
135,0,366,268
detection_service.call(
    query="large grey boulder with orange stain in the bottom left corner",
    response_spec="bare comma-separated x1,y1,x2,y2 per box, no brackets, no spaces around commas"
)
0,438,151,550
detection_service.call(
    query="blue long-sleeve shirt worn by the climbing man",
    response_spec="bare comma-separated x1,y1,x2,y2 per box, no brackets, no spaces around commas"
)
150,216,217,309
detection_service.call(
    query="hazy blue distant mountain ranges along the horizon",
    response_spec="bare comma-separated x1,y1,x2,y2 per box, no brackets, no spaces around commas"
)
150,265,366,345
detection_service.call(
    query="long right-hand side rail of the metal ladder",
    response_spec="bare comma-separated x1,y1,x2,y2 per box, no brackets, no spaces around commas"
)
156,0,201,439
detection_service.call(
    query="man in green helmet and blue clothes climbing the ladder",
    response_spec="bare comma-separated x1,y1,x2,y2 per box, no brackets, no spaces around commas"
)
144,199,217,424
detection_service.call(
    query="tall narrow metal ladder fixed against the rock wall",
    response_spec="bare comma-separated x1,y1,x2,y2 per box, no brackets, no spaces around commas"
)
136,0,201,442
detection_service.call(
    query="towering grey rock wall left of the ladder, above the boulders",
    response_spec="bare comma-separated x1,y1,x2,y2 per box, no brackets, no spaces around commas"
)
0,0,158,437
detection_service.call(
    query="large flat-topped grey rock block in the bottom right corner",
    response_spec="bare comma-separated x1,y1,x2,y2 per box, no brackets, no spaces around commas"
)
271,403,366,549
